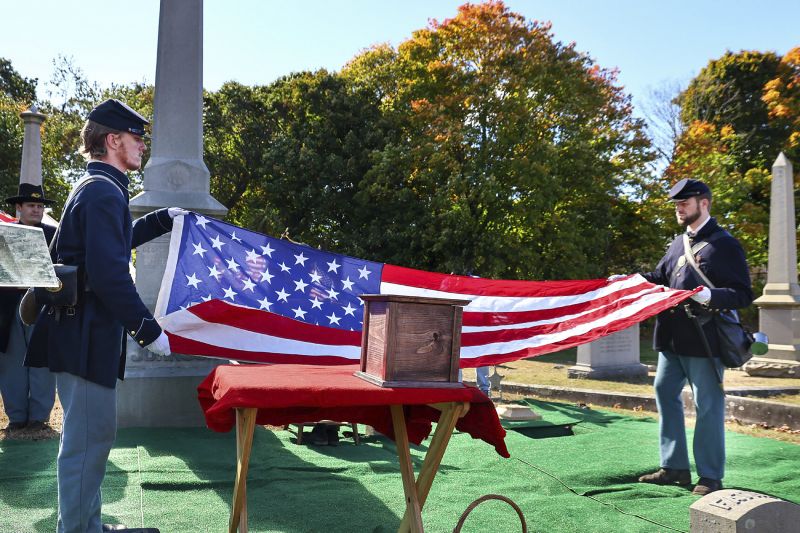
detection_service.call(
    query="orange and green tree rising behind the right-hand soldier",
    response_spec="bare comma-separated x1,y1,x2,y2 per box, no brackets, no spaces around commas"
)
665,49,800,268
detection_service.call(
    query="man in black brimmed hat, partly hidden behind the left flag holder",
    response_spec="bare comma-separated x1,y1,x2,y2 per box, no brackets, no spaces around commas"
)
0,183,56,432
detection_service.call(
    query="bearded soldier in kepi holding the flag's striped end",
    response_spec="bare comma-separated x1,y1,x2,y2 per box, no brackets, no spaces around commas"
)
639,179,753,495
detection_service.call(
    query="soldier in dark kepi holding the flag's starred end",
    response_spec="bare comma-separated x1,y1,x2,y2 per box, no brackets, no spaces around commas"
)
25,100,187,533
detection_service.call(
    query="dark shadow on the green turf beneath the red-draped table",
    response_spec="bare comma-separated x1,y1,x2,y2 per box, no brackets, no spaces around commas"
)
117,427,402,533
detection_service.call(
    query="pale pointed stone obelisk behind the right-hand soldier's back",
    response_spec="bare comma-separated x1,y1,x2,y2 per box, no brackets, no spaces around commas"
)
744,153,800,377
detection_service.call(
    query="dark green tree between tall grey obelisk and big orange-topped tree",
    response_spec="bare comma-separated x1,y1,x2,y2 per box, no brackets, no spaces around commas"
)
205,70,390,253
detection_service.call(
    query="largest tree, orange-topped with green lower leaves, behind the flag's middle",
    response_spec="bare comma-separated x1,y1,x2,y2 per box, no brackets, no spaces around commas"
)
342,1,661,279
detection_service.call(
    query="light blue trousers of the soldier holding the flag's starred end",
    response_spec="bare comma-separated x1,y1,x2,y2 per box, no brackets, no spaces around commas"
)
56,372,117,533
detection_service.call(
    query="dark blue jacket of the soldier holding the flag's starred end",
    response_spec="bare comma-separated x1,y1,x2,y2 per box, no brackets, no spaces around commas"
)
25,161,172,388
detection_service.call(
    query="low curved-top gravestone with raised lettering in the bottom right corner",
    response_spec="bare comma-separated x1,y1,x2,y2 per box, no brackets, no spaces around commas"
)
689,489,800,533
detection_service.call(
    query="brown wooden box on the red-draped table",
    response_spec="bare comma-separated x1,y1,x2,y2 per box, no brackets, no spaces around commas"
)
355,294,470,387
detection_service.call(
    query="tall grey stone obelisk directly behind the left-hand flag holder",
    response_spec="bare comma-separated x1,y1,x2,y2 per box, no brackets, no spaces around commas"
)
117,0,227,427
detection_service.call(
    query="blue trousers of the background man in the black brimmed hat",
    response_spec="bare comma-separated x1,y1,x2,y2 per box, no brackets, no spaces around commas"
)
0,313,56,424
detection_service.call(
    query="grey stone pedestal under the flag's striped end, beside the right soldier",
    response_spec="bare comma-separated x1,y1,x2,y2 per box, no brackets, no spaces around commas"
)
567,324,647,379
